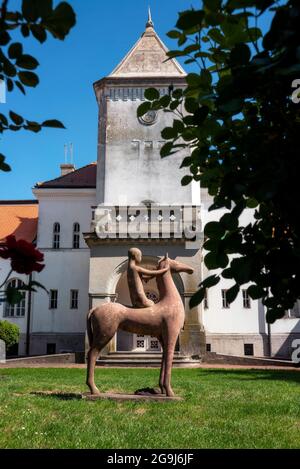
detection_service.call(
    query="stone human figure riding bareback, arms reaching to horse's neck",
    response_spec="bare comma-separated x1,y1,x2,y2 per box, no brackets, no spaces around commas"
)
127,248,168,308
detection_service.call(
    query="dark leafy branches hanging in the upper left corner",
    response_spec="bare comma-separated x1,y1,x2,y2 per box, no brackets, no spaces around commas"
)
0,0,76,171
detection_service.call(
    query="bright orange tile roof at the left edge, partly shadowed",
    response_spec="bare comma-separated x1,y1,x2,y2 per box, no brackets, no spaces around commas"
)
0,201,39,243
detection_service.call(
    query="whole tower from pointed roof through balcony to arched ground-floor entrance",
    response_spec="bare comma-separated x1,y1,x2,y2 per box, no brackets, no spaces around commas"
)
85,11,204,355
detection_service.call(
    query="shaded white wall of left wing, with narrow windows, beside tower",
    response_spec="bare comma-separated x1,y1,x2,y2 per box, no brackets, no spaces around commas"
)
31,189,96,333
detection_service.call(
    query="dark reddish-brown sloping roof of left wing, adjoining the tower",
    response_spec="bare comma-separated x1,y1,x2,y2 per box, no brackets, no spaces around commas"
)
35,163,97,189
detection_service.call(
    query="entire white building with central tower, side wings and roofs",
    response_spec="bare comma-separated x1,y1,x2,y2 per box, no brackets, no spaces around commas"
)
0,13,300,357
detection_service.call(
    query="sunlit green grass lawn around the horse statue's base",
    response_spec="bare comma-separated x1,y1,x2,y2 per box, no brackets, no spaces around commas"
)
0,368,300,449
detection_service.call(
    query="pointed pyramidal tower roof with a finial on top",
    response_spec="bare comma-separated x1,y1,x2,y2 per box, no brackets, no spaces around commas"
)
109,8,186,78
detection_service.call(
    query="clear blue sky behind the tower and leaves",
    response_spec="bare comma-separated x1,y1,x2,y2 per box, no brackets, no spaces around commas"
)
0,0,272,199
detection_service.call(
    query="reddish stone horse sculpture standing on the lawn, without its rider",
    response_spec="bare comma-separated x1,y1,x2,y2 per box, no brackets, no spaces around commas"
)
86,256,193,397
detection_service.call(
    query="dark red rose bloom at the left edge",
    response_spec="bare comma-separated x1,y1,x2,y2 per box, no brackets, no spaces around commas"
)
0,235,45,275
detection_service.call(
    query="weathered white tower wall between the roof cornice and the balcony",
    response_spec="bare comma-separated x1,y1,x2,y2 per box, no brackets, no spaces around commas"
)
98,92,192,205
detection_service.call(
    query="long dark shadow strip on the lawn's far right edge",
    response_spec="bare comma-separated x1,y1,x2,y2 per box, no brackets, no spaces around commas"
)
199,369,300,384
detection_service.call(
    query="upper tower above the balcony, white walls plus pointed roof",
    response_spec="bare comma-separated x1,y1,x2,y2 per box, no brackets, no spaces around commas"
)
94,11,195,205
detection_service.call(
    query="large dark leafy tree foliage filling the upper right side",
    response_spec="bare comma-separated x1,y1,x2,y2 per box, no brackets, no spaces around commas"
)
138,0,300,323
